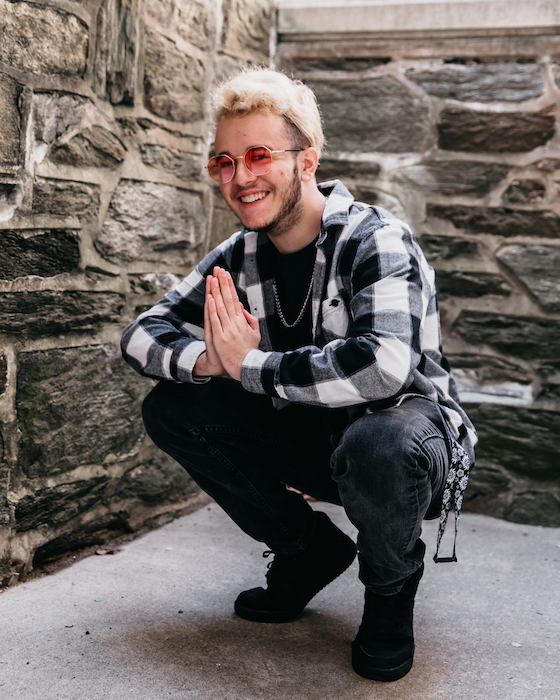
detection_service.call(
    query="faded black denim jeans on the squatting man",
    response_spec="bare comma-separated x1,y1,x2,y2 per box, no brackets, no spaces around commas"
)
143,378,449,595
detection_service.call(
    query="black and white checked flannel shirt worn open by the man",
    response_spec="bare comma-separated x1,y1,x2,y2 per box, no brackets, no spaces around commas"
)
122,180,476,556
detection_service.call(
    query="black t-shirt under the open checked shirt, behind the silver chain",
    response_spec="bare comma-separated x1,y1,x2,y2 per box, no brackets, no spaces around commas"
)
272,240,317,351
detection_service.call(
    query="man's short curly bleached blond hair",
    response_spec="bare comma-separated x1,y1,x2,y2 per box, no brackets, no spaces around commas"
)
212,68,325,157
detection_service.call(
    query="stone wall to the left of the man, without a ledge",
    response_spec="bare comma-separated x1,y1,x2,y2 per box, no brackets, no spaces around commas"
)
0,0,272,585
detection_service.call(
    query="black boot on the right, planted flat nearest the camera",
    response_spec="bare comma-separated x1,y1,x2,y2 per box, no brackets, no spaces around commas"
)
352,564,424,681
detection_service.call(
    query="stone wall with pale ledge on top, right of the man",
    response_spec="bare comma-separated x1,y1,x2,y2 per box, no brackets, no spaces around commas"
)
277,1,560,526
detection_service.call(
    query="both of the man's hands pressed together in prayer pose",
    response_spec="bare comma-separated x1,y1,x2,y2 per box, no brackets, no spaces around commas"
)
193,266,261,381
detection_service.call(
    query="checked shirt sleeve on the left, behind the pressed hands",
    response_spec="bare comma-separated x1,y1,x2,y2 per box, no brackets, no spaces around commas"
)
121,234,237,383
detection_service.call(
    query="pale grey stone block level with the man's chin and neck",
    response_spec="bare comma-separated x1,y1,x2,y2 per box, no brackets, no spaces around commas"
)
96,180,206,267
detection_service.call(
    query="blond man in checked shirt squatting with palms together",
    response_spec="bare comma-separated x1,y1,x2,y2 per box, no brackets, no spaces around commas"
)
123,69,476,681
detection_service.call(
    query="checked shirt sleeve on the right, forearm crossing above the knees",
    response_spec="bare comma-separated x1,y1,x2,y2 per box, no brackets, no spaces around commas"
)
241,220,433,408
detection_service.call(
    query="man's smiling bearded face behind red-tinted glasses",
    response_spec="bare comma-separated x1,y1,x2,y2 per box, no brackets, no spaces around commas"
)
215,114,304,238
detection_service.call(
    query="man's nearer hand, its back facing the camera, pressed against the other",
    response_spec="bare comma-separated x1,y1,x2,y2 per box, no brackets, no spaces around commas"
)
205,267,261,381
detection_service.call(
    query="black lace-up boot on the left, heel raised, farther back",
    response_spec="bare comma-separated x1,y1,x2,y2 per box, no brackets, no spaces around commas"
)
235,511,356,622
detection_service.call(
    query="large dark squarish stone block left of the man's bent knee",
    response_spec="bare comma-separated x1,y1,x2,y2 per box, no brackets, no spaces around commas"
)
16,344,150,482
